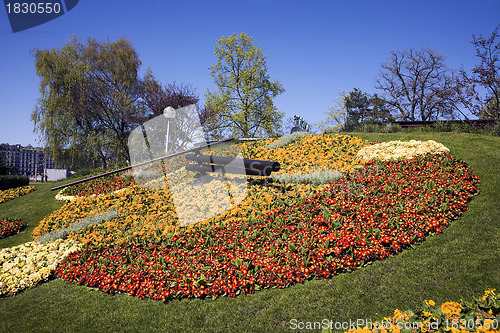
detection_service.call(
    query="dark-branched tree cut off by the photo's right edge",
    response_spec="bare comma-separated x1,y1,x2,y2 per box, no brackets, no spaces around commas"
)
454,25,500,122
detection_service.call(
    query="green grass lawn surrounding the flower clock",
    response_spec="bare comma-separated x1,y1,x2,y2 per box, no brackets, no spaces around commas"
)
0,132,500,332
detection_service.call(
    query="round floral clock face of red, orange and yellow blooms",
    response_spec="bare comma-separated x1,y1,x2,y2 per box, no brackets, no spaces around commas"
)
2,134,479,300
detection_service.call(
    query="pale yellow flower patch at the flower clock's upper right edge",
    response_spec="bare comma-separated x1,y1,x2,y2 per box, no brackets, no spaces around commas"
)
357,140,450,161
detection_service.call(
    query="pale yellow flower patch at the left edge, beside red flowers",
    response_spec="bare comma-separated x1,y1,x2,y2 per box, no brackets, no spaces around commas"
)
0,239,81,296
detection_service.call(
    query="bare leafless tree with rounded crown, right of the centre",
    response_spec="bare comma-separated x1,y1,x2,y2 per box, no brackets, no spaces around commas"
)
376,49,454,121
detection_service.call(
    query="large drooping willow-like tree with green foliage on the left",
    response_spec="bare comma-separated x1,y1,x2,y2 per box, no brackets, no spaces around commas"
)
32,37,146,168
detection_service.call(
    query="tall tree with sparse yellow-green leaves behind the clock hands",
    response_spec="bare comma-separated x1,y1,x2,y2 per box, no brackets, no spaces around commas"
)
205,33,285,137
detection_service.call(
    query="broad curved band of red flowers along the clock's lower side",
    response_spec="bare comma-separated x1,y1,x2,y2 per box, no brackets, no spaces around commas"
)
56,154,479,300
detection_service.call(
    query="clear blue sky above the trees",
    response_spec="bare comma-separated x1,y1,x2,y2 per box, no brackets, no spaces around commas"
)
0,0,500,145
